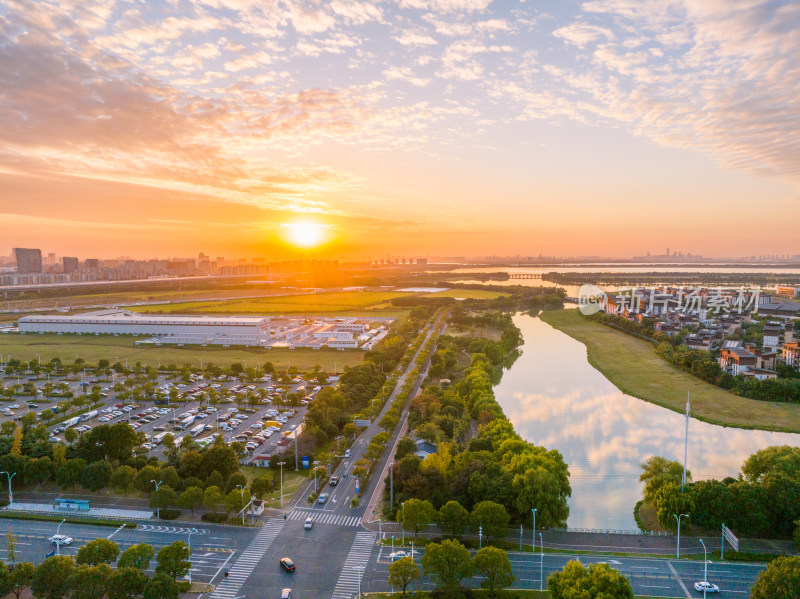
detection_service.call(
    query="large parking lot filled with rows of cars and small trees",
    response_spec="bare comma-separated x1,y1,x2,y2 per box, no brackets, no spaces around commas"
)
0,375,326,456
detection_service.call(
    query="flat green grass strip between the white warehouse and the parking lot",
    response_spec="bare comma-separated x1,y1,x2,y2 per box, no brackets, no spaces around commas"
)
0,334,364,372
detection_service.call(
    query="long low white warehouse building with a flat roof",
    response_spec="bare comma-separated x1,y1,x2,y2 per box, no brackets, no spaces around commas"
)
18,310,270,346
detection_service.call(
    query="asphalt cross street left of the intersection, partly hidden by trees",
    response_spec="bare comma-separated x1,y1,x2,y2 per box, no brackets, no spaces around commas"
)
0,519,257,582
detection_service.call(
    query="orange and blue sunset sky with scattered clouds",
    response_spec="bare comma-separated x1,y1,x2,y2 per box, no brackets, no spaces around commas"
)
0,0,800,258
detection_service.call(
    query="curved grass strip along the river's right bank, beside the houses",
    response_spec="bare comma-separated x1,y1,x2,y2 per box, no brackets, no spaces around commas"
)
541,310,800,433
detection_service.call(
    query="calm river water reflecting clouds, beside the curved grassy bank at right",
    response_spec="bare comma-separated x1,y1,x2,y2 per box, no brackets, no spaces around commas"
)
495,315,800,529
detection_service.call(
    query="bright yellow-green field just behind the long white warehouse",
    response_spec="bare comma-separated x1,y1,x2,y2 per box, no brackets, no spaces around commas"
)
131,291,409,314
